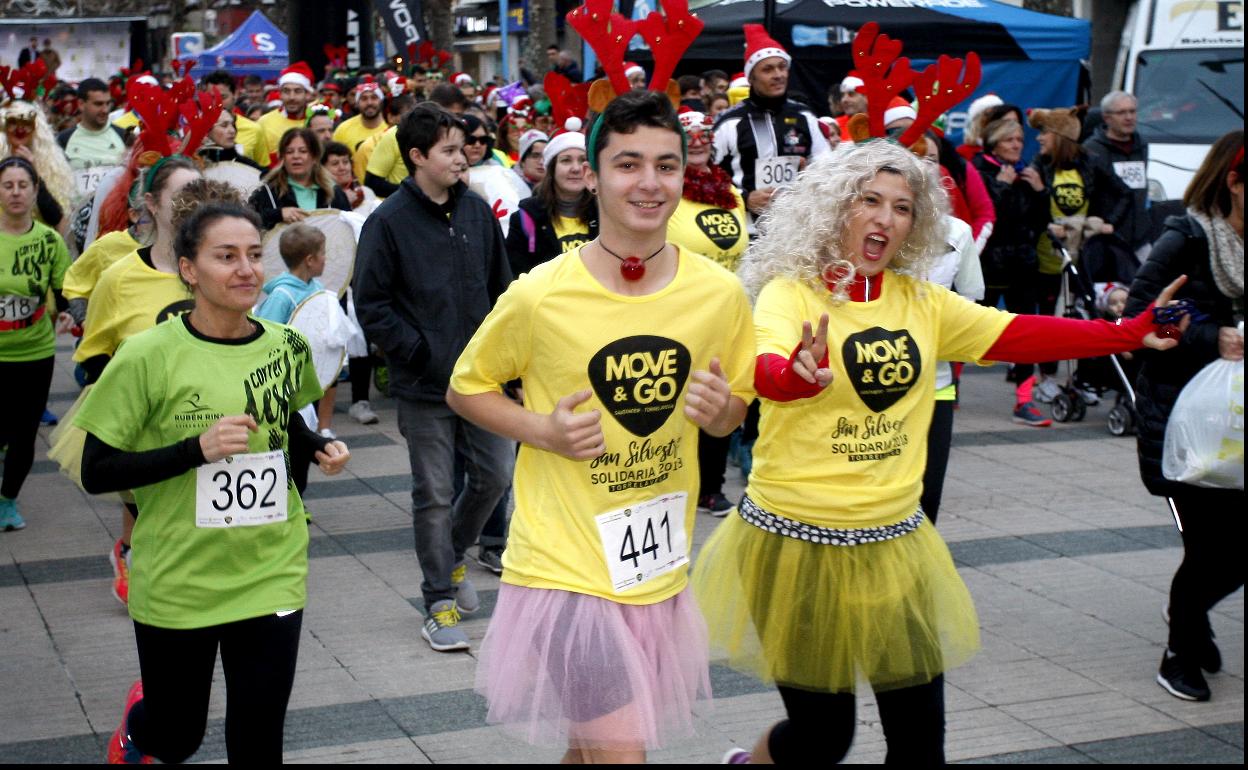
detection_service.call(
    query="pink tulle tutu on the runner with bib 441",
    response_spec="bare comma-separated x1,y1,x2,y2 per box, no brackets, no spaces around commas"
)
477,583,710,751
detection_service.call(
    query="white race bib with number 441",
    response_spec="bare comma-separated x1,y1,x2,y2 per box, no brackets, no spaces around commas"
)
594,492,689,593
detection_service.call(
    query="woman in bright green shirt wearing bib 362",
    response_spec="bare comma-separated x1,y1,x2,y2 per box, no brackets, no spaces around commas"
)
74,203,348,764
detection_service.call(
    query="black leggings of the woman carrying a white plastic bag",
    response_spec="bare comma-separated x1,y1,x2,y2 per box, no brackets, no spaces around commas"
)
1169,485,1244,655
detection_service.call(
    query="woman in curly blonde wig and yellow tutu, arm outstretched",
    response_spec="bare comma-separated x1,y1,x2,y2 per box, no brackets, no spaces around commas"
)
694,140,1186,764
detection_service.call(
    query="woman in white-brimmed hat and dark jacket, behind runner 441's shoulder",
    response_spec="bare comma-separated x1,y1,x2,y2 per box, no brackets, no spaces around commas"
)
507,130,598,277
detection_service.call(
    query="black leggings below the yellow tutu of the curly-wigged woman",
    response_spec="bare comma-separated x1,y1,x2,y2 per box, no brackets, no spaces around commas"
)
768,675,945,766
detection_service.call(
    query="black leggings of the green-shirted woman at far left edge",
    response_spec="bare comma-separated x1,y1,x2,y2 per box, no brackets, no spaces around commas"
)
0,356,54,500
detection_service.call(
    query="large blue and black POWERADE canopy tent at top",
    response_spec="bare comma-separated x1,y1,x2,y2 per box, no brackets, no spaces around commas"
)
650,0,1092,141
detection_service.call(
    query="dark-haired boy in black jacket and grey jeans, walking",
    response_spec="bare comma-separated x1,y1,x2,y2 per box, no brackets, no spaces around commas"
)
354,105,515,650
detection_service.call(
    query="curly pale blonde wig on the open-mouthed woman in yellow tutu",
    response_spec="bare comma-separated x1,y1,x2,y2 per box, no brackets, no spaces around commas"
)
738,140,947,302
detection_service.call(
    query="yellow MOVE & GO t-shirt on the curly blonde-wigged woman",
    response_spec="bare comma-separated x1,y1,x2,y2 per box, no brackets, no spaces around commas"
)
746,272,1013,528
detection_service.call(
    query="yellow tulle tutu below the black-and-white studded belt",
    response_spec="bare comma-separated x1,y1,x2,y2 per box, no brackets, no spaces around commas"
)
693,513,980,693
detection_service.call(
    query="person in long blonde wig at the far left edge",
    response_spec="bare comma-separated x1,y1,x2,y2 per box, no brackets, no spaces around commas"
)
0,99,74,235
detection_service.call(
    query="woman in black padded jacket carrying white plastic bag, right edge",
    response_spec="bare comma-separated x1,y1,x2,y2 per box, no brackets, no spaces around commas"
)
1126,131,1246,700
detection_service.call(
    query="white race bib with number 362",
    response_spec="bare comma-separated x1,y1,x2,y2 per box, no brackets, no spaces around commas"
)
195,449,286,529
